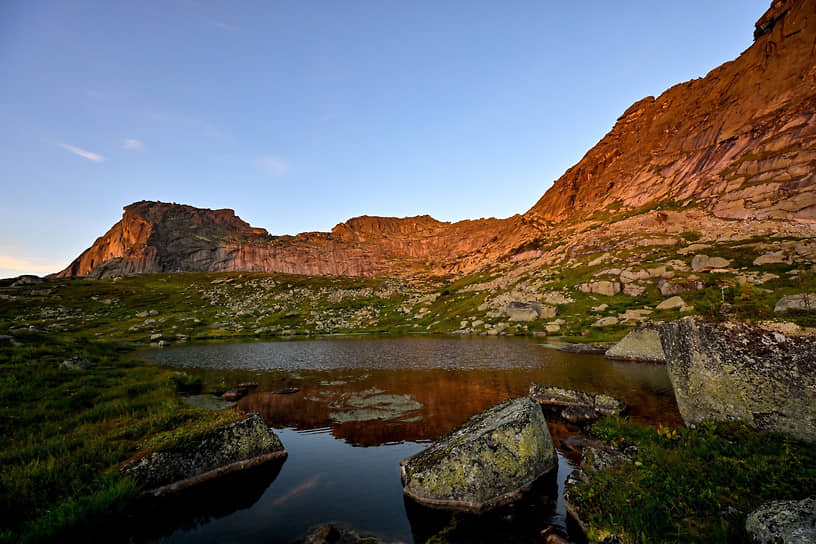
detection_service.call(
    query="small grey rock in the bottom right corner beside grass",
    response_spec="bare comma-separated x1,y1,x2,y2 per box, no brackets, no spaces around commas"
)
745,497,816,544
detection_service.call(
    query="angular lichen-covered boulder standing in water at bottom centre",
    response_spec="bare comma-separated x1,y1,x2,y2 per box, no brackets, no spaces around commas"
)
401,398,556,512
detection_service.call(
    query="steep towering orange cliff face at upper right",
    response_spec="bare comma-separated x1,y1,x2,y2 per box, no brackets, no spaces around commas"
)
525,0,816,223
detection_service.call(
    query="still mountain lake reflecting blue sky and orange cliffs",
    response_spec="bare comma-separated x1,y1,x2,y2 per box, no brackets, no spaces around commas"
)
140,337,681,543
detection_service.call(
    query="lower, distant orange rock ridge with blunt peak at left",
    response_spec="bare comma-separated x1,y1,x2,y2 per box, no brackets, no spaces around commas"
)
57,201,531,278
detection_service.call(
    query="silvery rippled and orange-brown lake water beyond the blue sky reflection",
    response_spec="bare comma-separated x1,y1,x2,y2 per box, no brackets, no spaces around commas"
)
145,337,682,446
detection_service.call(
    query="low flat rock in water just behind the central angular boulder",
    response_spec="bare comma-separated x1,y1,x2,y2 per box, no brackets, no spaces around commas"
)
530,383,629,424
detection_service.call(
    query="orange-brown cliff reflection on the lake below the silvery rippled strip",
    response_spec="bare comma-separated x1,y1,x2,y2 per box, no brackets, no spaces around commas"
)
239,360,680,446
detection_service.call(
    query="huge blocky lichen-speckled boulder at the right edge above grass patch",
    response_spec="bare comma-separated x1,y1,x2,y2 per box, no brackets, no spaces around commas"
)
659,318,816,440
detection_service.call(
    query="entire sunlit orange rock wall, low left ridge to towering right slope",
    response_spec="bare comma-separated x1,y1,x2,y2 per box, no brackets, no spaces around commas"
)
58,0,816,277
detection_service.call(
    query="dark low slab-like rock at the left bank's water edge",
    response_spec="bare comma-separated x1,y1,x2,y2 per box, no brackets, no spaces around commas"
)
120,414,286,496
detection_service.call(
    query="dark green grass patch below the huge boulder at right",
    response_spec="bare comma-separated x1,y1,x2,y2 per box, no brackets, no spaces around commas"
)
571,418,816,542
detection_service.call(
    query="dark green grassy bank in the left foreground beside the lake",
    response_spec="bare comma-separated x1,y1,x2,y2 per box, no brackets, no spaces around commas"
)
0,334,237,542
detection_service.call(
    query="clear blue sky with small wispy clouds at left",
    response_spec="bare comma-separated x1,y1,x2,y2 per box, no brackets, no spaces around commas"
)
0,0,770,277
